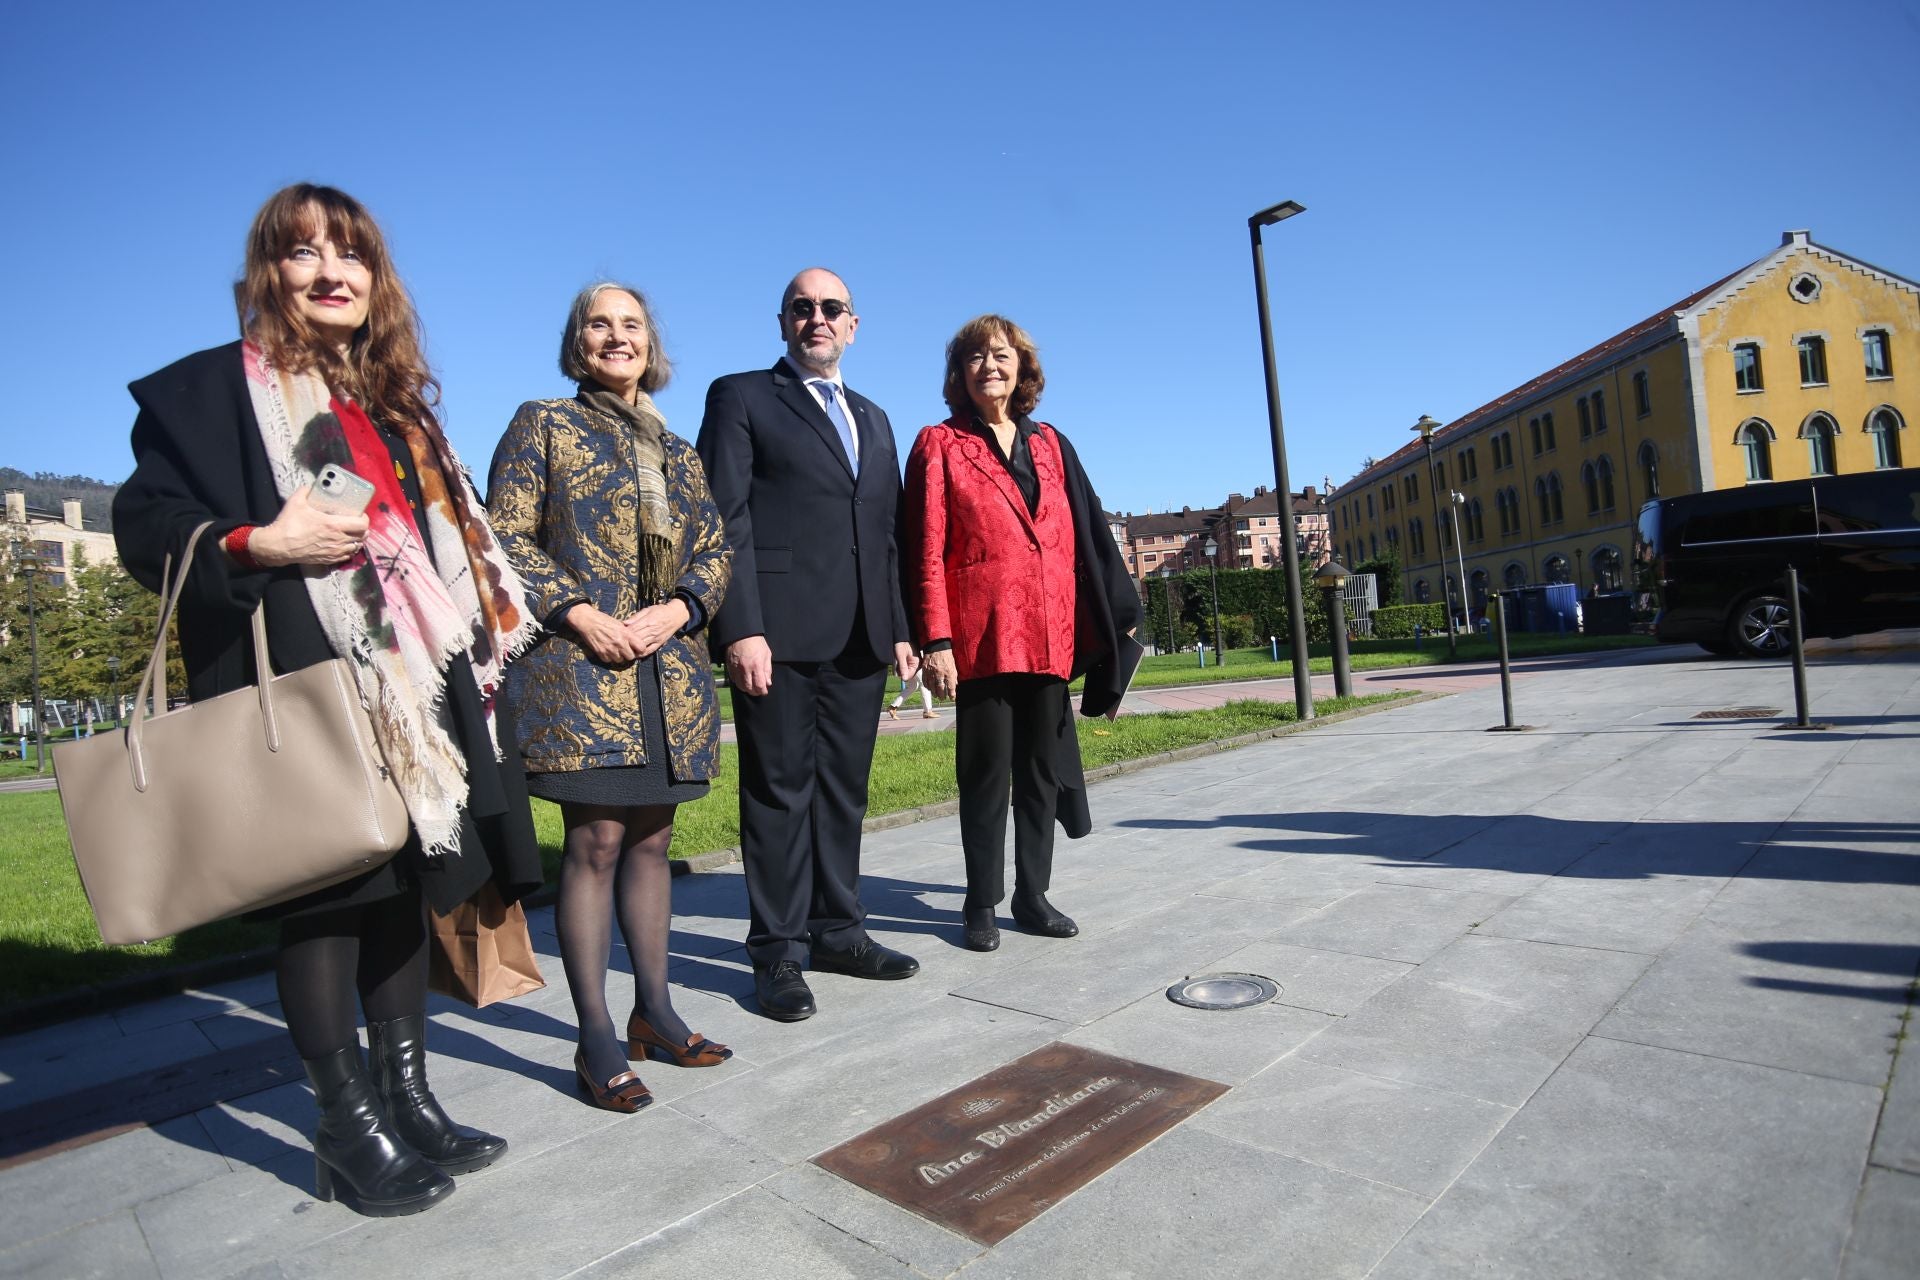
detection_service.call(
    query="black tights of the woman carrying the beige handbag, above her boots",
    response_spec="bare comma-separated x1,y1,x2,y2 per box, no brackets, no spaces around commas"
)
276,890,426,1057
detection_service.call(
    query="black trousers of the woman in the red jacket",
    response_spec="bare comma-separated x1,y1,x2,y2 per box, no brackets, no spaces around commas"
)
954,674,1068,910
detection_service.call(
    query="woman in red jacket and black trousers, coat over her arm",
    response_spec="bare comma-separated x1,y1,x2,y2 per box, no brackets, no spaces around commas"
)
900,315,1139,952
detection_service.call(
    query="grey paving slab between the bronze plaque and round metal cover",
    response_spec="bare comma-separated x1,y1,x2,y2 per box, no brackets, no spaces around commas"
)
1060,990,1336,1084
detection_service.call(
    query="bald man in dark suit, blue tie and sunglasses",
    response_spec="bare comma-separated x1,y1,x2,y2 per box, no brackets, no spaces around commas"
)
697,267,920,1021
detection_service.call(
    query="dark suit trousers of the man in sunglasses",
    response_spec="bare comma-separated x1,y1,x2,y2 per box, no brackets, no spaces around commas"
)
733,652,887,969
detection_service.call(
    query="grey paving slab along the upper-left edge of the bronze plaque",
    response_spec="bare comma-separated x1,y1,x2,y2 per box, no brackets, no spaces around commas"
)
672,996,1062,1163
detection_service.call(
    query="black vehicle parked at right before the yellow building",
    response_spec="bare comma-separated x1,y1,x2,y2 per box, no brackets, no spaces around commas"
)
1634,466,1920,658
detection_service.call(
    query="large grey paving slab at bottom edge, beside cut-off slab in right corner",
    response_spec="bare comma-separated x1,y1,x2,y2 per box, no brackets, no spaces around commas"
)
1375,1040,1874,1280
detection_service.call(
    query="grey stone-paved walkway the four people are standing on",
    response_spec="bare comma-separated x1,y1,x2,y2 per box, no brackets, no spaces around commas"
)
0,635,1920,1280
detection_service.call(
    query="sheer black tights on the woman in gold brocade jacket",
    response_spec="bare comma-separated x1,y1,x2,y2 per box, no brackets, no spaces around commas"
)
553,804,691,1082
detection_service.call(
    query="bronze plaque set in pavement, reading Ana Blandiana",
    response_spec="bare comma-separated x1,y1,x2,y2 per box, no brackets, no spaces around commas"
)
814,1044,1227,1245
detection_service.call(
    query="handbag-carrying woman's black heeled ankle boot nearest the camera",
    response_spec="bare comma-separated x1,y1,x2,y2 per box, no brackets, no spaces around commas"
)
300,1044,453,1219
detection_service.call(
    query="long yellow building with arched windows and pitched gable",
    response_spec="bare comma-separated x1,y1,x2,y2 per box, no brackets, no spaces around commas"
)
1329,230,1920,616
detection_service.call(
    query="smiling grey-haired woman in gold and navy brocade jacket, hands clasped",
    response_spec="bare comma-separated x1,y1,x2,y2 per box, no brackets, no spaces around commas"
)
488,282,732,1111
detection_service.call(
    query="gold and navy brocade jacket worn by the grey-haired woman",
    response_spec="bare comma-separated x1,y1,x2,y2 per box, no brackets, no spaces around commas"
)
488,399,733,783
